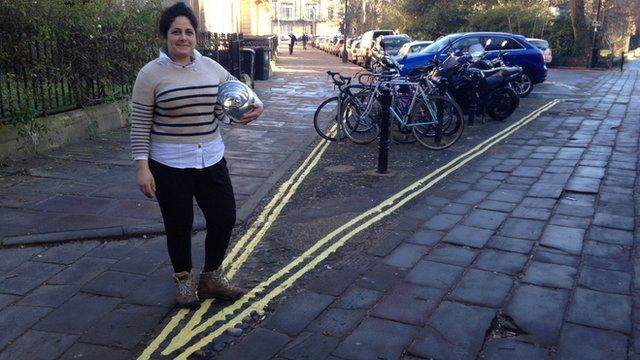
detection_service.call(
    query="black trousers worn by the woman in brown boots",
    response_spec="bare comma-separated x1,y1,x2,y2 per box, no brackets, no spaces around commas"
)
149,158,236,273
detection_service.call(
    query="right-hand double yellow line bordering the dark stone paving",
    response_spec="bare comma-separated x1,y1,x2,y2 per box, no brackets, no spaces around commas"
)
169,99,562,359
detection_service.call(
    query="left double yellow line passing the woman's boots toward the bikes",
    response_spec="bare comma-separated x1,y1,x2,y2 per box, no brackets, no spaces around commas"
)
138,129,338,360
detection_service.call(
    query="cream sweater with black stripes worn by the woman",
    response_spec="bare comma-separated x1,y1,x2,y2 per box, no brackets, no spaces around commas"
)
131,52,233,158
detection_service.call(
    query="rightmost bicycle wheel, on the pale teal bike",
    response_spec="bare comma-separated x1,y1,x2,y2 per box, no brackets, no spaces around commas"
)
409,95,464,150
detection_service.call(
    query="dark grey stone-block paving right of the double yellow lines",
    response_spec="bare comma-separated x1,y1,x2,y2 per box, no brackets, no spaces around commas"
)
215,64,640,359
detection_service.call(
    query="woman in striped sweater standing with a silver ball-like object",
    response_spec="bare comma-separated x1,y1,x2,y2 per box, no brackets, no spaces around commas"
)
131,2,263,306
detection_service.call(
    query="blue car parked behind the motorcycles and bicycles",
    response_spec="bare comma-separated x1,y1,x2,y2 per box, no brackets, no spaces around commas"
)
394,32,547,85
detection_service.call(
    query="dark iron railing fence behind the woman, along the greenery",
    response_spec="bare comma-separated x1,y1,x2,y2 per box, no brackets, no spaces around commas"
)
0,33,248,123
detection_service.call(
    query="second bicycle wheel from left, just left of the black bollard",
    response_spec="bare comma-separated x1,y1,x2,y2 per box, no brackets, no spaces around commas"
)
343,91,380,145
